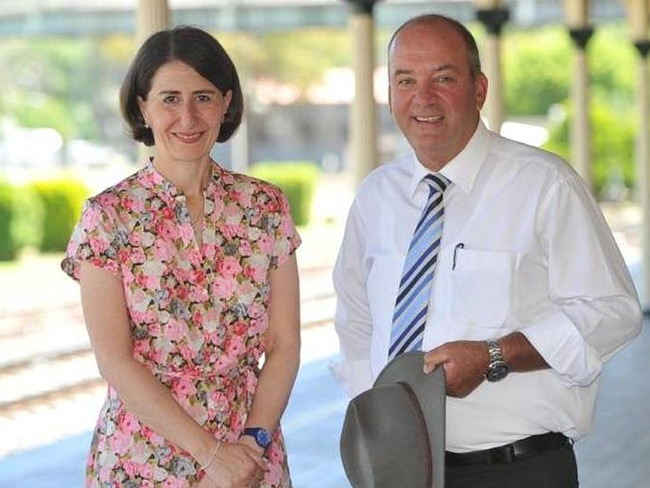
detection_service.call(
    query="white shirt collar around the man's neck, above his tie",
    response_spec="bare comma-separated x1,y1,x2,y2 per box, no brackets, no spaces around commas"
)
409,121,491,195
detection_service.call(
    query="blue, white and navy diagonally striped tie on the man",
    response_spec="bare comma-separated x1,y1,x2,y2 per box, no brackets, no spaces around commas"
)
388,174,449,360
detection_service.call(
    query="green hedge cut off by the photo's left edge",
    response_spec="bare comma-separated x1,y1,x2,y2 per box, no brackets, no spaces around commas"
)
0,181,43,261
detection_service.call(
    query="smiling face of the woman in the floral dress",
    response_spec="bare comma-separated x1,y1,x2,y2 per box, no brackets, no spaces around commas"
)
138,60,232,165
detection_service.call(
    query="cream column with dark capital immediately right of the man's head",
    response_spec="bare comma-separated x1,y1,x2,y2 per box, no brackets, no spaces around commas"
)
476,0,510,132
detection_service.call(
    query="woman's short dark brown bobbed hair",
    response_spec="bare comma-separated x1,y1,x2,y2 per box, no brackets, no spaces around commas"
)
120,25,244,146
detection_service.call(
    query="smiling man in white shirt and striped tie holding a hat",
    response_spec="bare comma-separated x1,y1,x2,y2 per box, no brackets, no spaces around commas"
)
333,15,641,488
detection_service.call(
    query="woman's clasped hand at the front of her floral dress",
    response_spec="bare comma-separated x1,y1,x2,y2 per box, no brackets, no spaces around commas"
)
197,442,268,488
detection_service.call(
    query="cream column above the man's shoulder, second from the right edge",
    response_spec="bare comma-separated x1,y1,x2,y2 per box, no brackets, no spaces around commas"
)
564,0,594,190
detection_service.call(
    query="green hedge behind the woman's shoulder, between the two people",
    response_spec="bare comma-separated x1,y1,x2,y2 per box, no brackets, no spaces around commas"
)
250,161,320,226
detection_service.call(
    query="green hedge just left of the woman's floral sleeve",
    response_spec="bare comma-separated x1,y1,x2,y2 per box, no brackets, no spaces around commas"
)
30,178,89,252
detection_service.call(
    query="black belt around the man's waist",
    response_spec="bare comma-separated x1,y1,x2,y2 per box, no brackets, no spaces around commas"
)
445,432,573,467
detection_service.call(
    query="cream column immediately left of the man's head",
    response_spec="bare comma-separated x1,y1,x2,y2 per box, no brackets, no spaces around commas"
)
346,0,379,186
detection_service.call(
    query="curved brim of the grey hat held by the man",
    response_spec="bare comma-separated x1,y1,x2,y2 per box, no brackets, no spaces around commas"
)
374,351,447,488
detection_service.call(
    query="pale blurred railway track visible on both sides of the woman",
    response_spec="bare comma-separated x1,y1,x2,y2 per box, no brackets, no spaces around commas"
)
0,268,335,419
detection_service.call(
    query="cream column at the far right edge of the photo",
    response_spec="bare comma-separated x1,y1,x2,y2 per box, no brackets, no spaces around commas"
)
626,0,650,313
